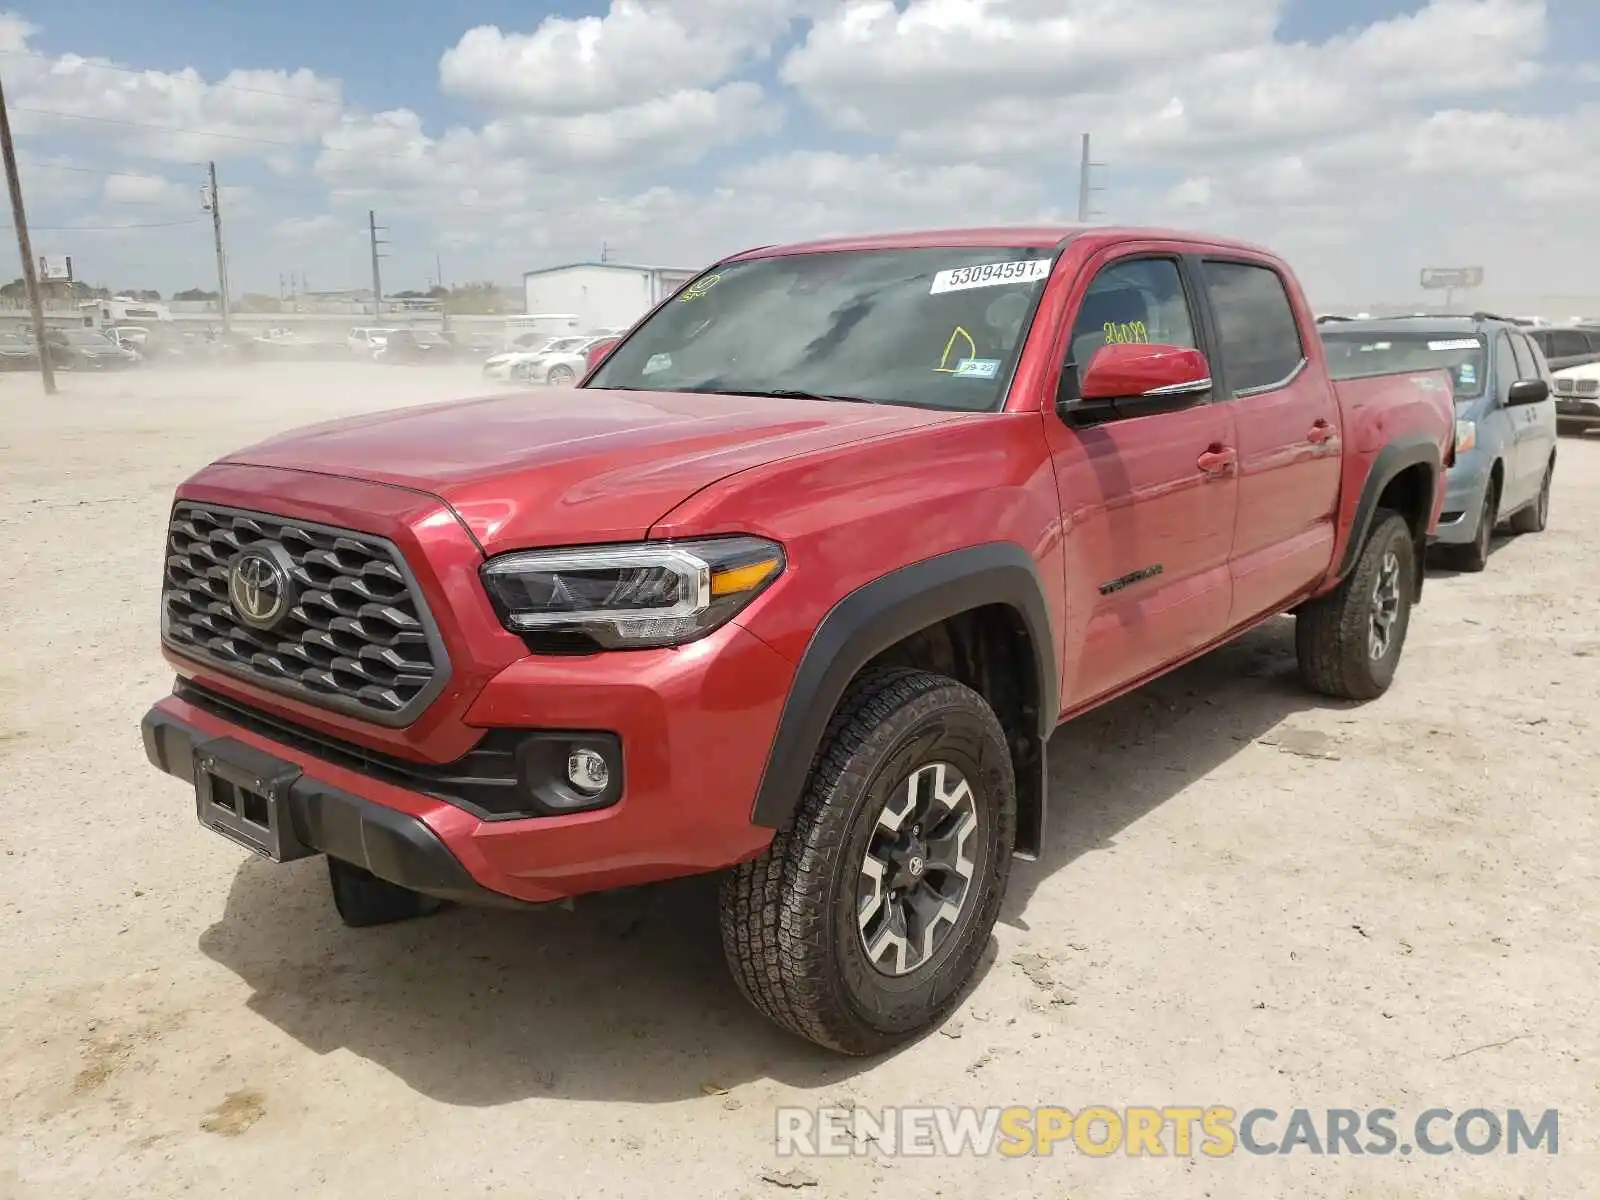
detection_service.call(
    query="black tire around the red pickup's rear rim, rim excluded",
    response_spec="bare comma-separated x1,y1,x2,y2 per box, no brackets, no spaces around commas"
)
1294,509,1418,701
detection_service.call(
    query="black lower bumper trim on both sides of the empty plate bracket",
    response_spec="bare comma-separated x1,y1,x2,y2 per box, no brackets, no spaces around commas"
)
139,709,530,909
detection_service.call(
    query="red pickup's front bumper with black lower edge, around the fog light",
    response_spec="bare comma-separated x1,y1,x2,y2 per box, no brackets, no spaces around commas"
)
144,624,794,902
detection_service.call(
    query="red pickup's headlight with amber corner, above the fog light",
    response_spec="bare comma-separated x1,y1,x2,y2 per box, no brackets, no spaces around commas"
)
482,538,784,650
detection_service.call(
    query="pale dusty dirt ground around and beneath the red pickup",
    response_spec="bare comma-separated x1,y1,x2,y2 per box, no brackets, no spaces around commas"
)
0,366,1600,1200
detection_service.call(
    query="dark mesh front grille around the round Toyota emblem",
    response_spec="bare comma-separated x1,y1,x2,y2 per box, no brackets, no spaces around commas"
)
162,502,448,725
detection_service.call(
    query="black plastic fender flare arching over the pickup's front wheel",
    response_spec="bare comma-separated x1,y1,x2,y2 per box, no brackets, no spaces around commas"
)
750,542,1061,851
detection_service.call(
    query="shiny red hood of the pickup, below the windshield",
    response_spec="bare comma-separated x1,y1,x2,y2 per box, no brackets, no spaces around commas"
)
222,389,962,554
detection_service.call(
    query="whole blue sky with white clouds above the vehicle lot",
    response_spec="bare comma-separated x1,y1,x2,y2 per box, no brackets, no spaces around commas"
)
9,0,1600,307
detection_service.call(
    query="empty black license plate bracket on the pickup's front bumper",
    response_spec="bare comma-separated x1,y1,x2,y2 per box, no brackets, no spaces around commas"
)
194,738,317,862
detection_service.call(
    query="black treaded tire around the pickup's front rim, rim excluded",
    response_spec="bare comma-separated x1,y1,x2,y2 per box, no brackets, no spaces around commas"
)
722,669,1016,1054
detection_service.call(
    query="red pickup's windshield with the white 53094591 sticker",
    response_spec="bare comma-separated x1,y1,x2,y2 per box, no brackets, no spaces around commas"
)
587,246,1051,411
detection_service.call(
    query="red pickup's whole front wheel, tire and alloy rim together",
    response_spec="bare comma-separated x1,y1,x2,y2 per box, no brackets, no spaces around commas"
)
722,669,1016,1054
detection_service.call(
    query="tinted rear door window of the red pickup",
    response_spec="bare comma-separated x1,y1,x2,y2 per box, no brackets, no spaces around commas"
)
1205,261,1306,395
